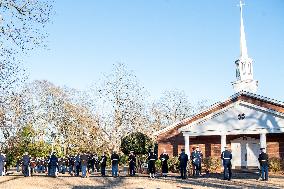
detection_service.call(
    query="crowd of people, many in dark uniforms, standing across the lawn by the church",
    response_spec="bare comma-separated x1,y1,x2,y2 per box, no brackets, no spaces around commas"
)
0,146,268,180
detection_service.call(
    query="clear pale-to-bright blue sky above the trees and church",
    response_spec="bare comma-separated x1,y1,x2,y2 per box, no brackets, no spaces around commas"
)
25,0,284,102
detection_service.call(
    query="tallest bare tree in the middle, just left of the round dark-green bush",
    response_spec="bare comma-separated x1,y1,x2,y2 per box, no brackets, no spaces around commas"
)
95,63,150,150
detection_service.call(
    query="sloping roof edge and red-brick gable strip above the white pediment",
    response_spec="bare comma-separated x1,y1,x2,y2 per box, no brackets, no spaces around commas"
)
155,91,284,140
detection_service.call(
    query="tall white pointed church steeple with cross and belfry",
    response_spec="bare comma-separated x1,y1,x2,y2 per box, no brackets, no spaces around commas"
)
232,0,258,93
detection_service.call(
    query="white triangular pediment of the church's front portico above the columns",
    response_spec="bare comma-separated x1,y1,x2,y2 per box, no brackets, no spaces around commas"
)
178,100,284,136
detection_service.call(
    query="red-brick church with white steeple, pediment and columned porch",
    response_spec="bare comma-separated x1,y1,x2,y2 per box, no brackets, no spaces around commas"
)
157,0,284,168
